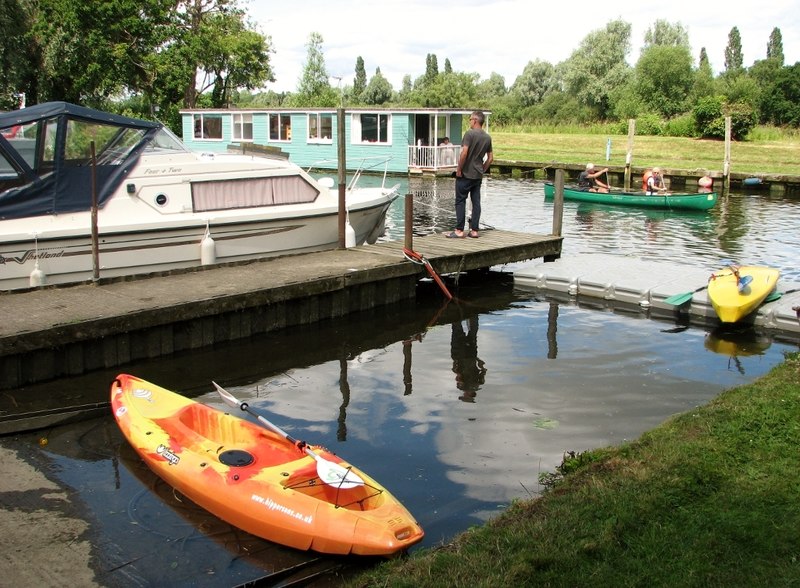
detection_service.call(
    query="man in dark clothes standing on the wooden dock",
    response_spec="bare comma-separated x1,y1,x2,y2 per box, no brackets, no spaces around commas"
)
446,110,494,239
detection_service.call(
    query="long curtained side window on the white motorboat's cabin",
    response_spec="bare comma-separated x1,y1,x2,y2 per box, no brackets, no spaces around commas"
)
192,176,319,212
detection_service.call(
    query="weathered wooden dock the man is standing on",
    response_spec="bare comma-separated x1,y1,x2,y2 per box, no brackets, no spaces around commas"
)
0,230,563,390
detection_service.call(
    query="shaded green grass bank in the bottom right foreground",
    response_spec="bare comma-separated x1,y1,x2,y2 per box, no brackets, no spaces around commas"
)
352,354,800,587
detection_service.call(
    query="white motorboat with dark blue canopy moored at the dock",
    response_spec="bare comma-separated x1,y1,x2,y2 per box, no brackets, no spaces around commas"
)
0,102,398,290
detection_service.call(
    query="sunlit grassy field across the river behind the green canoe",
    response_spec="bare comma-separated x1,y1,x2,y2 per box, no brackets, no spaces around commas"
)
490,129,800,176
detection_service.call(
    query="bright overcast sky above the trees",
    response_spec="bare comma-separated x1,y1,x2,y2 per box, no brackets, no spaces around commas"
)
243,0,800,92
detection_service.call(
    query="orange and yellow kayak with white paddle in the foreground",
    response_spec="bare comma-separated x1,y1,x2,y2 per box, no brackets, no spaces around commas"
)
111,374,424,556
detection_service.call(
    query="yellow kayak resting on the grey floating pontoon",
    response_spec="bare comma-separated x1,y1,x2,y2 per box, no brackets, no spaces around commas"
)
708,265,780,323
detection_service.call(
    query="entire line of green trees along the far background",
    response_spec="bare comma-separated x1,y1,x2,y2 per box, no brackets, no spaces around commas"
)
0,0,800,139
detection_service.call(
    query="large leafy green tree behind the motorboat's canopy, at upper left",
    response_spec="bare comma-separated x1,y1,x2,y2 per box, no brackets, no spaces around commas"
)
14,0,272,117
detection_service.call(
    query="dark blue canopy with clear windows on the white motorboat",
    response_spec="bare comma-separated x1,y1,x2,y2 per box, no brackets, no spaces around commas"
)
0,102,163,219
